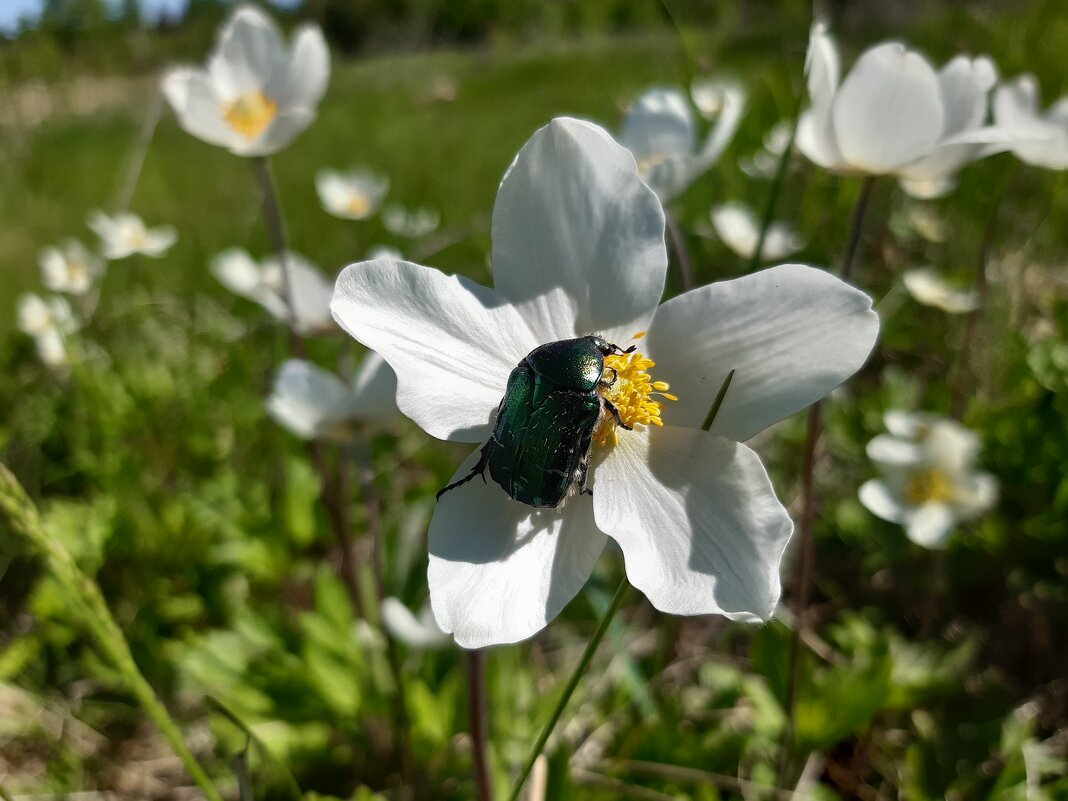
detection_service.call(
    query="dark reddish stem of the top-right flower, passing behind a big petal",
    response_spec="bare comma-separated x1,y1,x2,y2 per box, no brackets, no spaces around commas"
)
778,175,875,786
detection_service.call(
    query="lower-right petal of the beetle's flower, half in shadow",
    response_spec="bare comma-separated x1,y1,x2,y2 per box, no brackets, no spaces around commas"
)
593,426,794,621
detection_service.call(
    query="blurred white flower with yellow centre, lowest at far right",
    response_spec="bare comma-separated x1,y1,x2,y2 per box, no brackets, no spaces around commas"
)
859,411,998,548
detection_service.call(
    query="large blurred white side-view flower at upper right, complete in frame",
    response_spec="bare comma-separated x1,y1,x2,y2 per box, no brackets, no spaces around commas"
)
797,21,1010,198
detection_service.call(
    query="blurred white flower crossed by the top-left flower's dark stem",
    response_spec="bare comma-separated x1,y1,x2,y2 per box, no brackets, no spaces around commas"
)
210,248,336,334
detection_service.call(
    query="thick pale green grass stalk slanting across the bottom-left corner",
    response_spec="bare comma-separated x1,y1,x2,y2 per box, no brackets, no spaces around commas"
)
0,464,222,801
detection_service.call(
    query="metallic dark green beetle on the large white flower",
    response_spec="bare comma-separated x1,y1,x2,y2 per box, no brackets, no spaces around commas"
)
438,336,635,507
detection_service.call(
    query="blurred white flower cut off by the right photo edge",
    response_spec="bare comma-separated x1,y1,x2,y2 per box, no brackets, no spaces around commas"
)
993,75,1068,170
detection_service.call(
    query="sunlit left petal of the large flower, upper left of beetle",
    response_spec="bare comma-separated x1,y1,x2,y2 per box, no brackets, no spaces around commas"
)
331,258,540,442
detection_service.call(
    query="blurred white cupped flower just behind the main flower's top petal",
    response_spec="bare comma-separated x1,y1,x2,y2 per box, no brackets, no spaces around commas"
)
619,83,745,203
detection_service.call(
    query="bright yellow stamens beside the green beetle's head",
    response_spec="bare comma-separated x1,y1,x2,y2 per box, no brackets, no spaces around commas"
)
594,334,678,447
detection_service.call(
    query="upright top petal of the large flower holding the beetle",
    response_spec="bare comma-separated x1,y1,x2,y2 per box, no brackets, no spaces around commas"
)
493,117,668,342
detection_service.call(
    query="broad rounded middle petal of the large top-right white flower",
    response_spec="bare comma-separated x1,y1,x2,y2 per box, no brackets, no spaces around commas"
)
833,43,945,175
